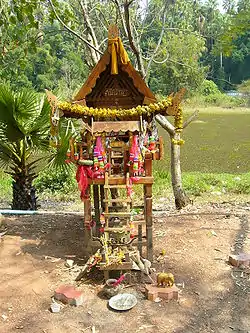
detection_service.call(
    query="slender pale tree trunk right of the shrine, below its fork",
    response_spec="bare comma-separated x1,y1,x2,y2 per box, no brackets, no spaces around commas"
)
170,133,191,210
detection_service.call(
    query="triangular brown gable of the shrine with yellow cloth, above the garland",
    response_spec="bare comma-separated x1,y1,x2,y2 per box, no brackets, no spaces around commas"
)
74,26,156,109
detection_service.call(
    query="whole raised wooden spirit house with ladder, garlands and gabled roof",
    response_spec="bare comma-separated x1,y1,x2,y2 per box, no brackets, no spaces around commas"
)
49,26,184,276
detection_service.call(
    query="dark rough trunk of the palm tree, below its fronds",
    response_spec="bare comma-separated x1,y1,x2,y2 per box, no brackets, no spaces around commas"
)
12,172,37,210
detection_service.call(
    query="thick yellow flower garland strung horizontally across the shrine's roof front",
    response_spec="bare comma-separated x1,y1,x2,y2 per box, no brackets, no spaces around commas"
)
58,97,173,118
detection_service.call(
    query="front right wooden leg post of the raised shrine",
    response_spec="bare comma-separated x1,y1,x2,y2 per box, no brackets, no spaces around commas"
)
144,184,153,262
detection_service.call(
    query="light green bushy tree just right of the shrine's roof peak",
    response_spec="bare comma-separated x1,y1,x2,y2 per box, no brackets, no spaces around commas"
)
149,31,207,95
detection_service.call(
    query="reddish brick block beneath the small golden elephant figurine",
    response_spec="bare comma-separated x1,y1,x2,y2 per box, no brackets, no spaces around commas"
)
145,284,179,301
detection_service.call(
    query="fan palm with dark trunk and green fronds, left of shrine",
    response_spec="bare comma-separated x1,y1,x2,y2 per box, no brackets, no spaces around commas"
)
0,84,50,210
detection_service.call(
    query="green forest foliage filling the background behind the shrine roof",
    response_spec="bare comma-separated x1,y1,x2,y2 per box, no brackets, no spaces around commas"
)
0,0,250,98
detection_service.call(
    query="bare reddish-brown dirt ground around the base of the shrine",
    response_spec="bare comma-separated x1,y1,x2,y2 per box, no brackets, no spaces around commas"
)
0,202,250,333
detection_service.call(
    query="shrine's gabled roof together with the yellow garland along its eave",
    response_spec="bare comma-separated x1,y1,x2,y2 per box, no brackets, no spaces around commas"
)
52,26,185,121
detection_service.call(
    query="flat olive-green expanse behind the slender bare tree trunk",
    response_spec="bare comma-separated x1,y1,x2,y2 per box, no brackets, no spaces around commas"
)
155,107,250,174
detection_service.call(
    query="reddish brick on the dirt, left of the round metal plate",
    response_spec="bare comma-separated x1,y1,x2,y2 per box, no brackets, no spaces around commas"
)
54,285,83,306
